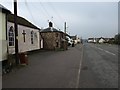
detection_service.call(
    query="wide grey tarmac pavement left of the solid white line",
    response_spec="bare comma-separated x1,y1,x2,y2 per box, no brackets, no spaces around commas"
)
2,44,82,88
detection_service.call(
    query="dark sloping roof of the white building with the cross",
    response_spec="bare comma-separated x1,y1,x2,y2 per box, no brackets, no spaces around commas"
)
8,14,40,30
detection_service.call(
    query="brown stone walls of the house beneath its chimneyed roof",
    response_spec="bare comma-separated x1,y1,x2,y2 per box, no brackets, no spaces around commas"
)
41,32,65,50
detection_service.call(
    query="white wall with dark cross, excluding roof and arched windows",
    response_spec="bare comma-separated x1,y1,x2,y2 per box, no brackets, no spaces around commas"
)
7,22,40,53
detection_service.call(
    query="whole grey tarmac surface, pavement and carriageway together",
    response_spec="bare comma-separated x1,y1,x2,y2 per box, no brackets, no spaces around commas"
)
3,43,118,88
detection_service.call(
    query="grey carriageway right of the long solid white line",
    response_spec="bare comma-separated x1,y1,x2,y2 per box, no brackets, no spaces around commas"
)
79,43,118,88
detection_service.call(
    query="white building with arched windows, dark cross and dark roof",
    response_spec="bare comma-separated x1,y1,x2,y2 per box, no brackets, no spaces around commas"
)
7,14,43,54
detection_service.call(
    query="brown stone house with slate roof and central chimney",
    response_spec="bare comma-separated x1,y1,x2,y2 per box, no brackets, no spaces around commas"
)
40,22,67,50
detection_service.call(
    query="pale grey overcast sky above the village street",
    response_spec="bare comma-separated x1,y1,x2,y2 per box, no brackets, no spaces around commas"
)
0,0,118,38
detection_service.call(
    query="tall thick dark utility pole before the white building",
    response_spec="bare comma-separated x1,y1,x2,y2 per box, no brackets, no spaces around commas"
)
14,0,19,65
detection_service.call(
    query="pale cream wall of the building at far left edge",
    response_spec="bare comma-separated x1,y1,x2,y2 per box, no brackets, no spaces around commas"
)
0,12,7,61
